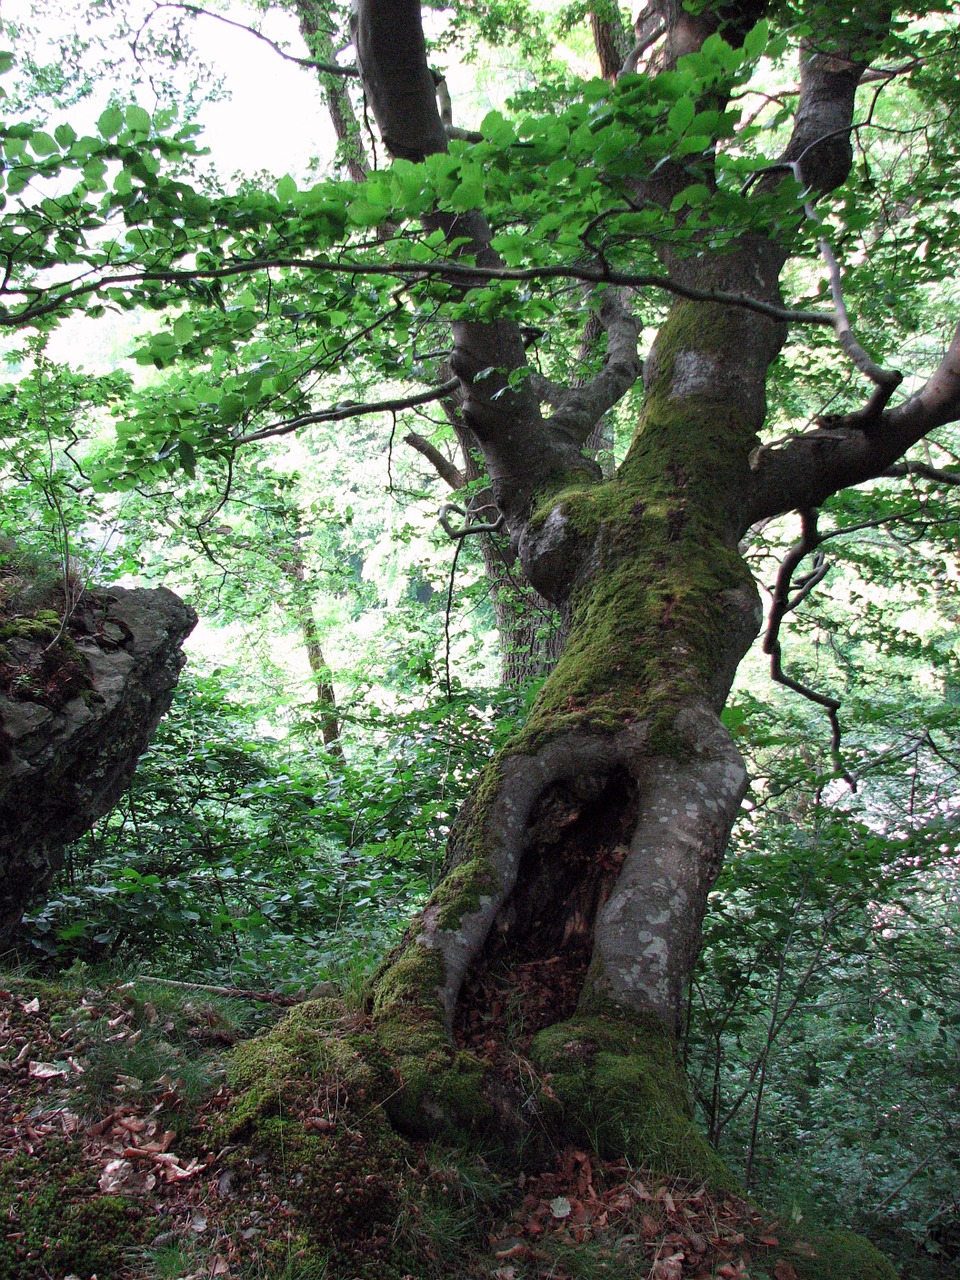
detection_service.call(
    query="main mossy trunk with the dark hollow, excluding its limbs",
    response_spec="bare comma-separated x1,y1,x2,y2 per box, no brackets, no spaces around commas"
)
378,290,780,1171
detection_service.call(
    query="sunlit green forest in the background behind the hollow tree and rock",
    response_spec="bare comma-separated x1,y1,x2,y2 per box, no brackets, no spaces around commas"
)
0,0,960,1280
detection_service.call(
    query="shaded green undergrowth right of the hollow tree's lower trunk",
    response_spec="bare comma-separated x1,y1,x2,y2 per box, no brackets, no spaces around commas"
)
687,660,960,1280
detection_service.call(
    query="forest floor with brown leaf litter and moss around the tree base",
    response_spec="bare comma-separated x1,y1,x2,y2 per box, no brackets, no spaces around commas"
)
0,973,812,1280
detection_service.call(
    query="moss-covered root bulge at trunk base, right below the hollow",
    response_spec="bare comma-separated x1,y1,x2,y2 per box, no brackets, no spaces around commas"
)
530,1010,736,1189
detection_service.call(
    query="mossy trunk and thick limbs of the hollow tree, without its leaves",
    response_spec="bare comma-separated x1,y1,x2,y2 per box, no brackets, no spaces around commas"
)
345,0,960,1171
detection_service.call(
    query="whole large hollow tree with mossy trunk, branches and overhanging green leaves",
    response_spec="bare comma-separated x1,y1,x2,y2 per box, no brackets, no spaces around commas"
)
3,0,960,1269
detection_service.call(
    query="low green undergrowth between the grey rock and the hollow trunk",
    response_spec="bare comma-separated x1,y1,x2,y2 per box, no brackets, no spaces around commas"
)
26,676,537,987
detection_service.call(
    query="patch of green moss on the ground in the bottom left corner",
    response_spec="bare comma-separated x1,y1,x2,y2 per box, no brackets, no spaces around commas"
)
0,1140,145,1280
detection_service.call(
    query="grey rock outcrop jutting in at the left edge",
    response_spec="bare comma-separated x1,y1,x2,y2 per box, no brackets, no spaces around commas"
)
0,588,197,950
